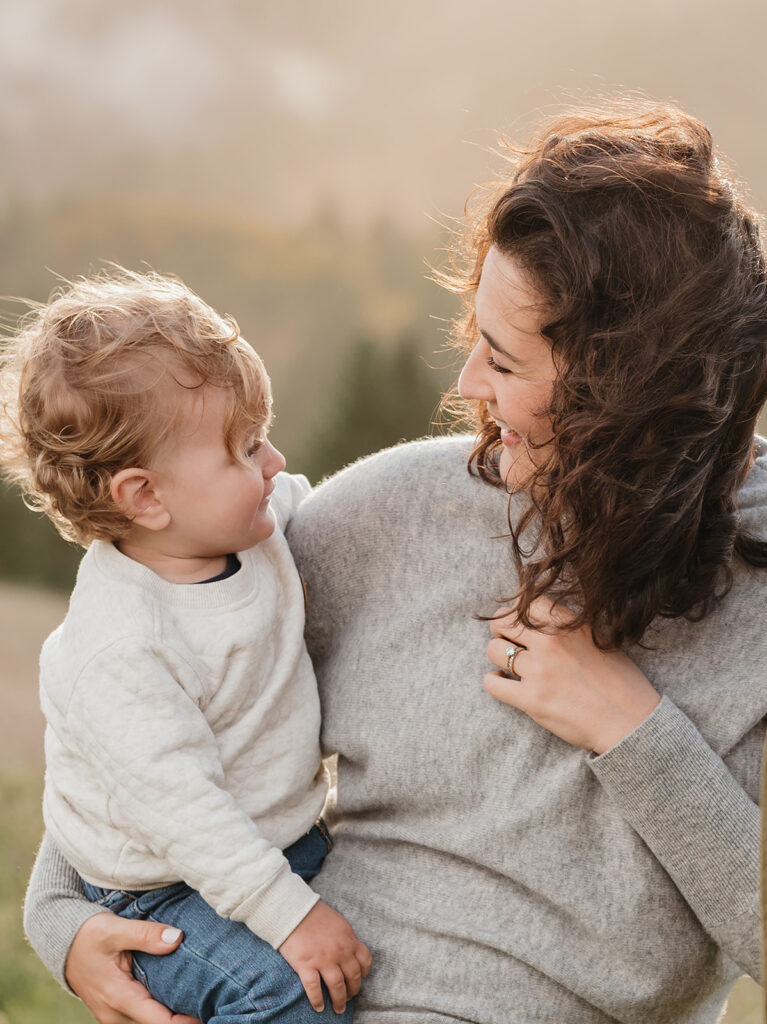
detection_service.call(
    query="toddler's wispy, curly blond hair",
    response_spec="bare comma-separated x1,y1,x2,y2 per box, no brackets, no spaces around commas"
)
0,267,271,545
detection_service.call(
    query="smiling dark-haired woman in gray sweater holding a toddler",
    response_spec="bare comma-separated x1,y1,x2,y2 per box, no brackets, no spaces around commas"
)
27,104,767,1024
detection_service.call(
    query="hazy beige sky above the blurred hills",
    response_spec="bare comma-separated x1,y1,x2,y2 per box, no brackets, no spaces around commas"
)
0,0,767,226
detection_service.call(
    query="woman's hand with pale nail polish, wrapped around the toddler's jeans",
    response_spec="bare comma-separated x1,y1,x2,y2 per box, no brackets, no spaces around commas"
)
65,913,201,1024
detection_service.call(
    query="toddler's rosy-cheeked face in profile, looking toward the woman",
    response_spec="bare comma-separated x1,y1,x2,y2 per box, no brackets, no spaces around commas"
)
154,387,285,558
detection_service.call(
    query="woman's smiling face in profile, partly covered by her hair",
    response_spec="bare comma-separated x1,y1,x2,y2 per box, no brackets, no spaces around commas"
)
458,247,556,490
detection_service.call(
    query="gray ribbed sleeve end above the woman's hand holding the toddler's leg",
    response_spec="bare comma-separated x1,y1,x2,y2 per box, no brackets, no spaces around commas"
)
24,833,111,991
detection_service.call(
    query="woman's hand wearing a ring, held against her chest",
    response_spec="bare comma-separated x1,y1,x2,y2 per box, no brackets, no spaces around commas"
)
484,598,661,754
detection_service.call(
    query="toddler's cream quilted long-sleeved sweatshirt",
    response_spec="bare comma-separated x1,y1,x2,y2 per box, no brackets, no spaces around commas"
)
40,473,326,947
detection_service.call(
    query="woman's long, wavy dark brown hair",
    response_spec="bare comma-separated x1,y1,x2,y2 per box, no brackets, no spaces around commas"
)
444,100,767,647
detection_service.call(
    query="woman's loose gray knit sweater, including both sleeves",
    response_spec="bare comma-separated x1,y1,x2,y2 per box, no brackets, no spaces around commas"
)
26,437,767,1024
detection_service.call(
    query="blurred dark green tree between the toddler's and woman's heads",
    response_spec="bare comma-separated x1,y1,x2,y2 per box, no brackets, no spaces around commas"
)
296,337,441,481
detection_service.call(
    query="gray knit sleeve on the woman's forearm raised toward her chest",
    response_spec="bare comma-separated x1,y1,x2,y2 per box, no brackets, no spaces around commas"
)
589,696,764,980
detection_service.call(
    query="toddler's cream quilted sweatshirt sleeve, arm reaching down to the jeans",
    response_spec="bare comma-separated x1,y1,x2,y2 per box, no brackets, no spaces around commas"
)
48,640,318,948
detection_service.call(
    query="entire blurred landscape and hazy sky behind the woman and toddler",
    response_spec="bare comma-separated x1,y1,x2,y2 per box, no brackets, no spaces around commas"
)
0,0,767,1024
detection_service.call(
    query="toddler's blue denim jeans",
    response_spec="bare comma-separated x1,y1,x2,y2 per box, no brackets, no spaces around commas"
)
83,821,352,1024
